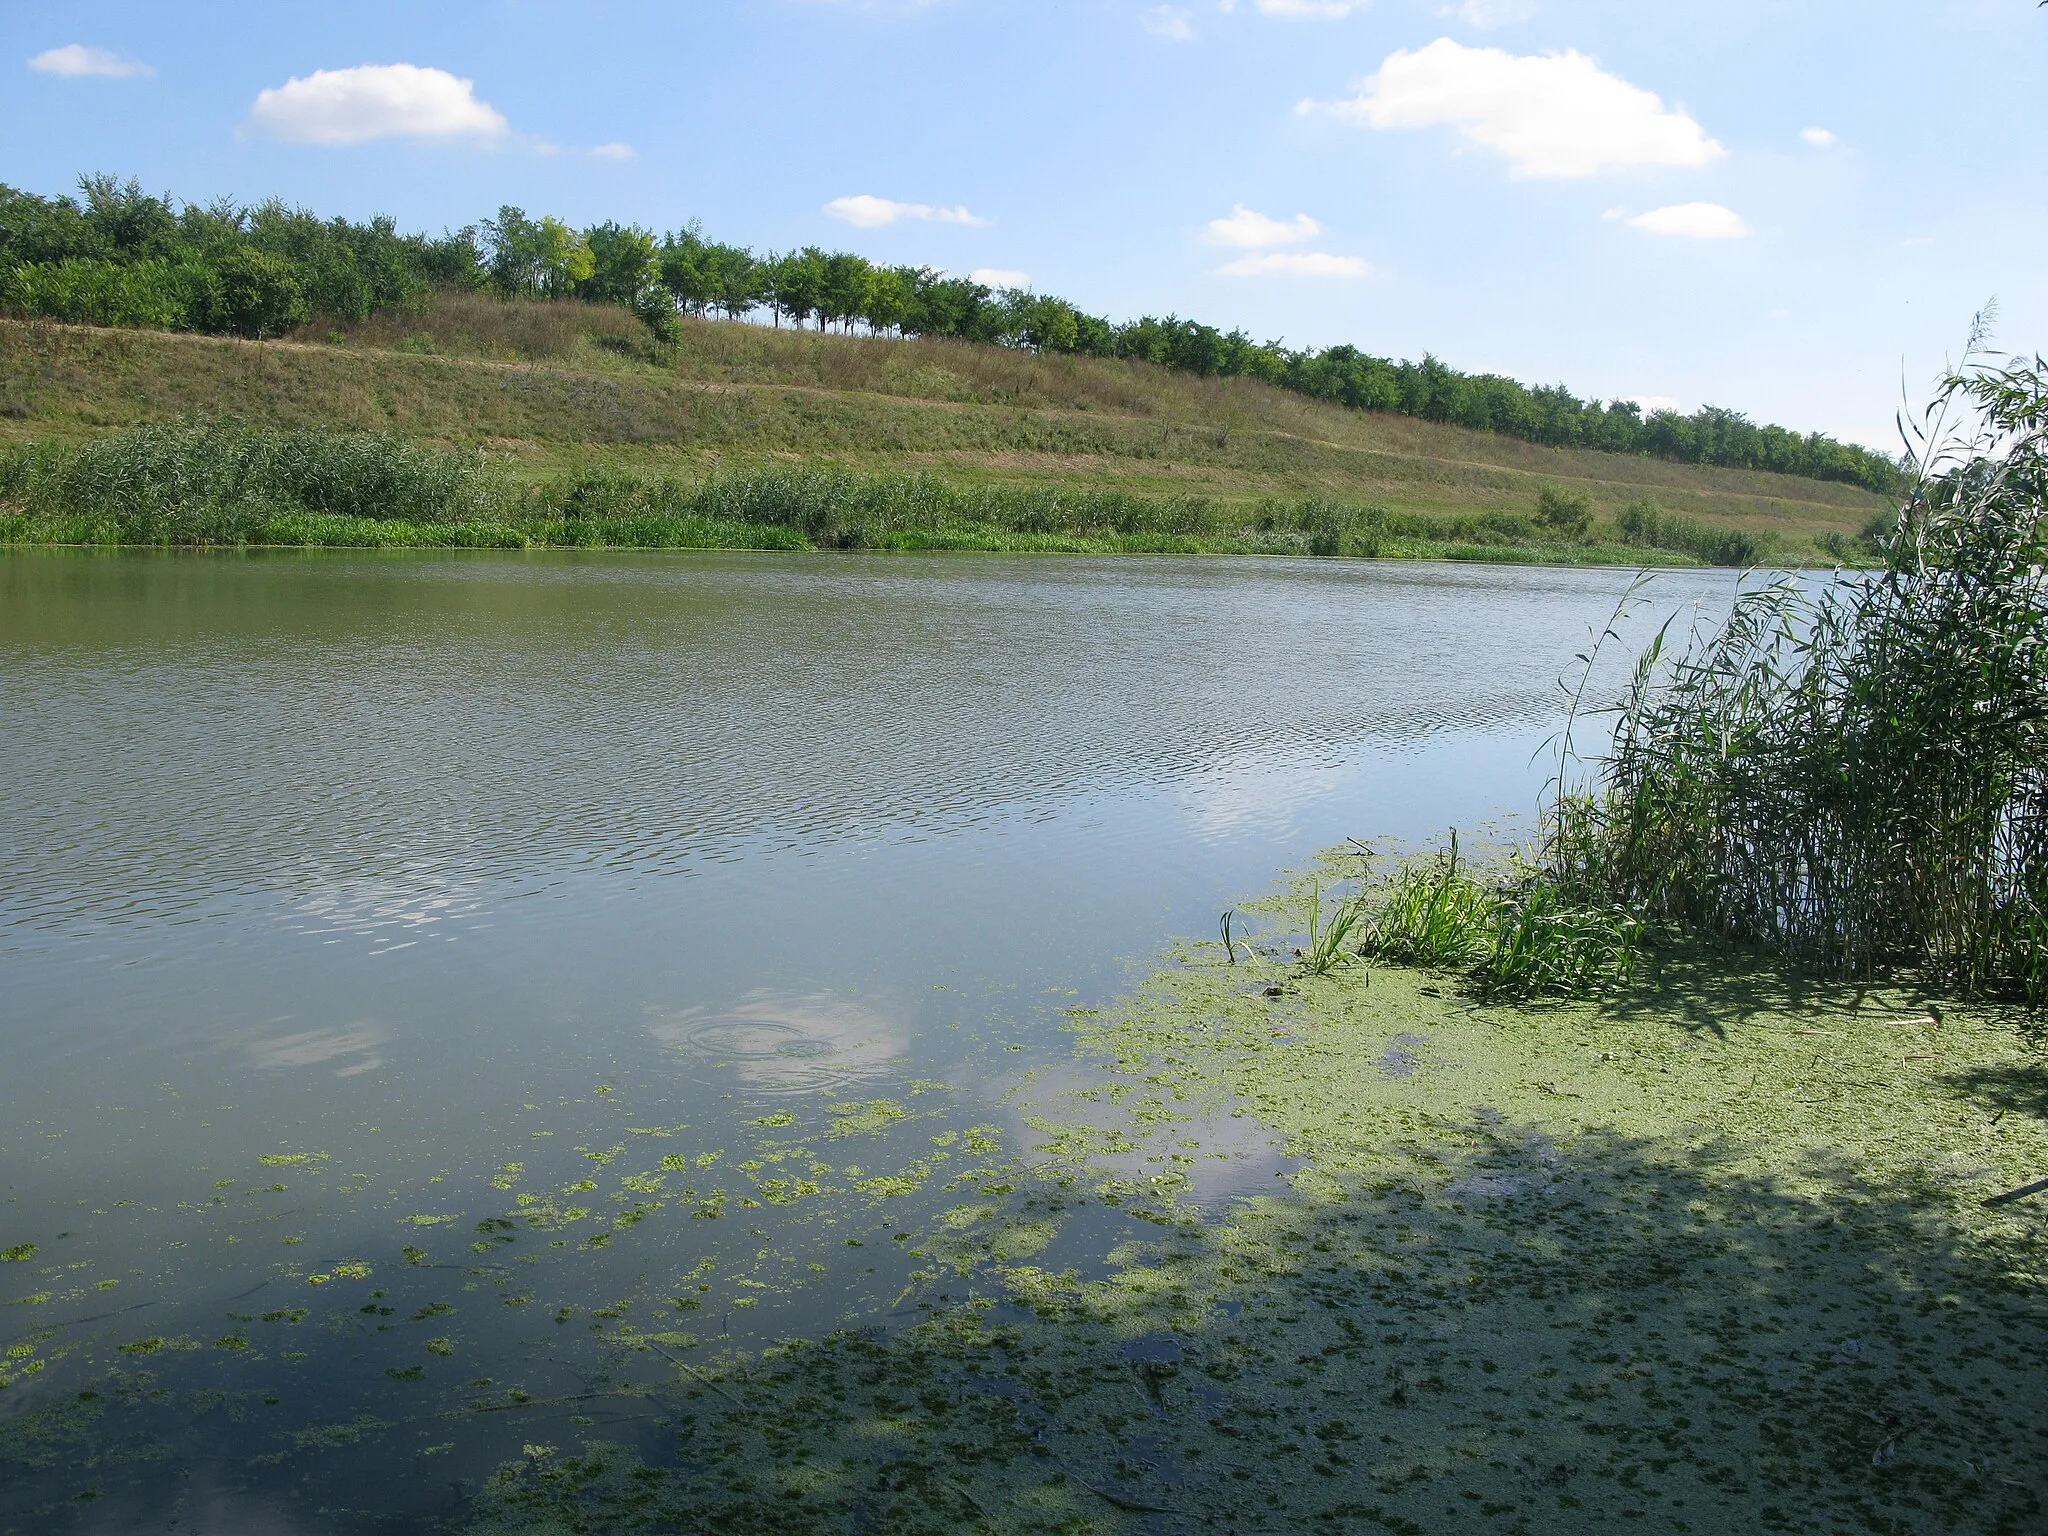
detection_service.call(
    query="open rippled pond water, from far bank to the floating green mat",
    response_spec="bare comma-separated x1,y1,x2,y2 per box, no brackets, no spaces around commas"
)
0,551,1729,1530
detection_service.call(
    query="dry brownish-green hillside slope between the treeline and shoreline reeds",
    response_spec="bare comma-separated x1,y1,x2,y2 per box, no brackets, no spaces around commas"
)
0,295,1886,557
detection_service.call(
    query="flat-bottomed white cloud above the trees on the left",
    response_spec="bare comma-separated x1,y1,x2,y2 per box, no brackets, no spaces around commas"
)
244,63,508,145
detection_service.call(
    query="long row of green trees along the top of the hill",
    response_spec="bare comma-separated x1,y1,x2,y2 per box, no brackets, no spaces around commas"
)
0,176,1903,492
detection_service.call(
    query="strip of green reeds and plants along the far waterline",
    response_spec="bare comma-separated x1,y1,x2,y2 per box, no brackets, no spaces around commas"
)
0,421,1843,573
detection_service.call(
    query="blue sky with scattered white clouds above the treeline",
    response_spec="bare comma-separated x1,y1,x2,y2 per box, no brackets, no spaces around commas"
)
0,0,2048,451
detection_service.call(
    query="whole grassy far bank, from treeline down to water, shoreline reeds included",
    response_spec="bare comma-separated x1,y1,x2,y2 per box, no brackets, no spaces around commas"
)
0,295,1884,563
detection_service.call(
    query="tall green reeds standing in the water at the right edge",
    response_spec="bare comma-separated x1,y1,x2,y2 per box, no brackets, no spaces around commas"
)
1550,342,2048,1001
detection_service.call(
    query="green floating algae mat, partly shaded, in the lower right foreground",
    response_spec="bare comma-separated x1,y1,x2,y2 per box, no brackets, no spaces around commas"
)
452,876,2048,1532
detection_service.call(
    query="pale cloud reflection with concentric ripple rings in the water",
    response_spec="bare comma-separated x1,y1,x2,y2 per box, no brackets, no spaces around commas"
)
647,987,909,1094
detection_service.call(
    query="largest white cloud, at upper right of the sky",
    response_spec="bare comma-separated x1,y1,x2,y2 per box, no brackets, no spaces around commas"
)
1303,37,1726,176
